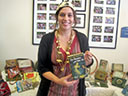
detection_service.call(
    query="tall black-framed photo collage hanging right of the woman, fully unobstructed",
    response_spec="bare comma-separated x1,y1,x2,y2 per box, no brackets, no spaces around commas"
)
88,0,120,49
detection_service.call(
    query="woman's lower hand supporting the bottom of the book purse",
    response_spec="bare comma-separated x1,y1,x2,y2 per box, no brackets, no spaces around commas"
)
56,74,77,87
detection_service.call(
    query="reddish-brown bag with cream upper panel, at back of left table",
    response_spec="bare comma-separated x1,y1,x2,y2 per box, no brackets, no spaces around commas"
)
17,58,34,73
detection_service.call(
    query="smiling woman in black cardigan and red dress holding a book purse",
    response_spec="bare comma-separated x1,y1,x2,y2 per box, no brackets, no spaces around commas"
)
37,2,92,96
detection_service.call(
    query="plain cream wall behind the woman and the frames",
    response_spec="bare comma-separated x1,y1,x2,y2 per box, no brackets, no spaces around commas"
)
0,0,128,71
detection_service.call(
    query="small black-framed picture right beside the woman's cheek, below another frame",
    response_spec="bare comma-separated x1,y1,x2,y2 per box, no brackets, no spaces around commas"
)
75,14,85,28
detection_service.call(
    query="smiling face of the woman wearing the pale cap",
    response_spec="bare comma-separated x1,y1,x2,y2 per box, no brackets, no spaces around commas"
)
58,7,74,30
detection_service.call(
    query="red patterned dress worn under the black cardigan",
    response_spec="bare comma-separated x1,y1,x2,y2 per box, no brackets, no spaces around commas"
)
48,36,80,96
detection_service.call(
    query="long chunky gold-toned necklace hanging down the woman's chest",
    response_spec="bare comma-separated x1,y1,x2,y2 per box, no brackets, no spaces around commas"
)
56,30,73,71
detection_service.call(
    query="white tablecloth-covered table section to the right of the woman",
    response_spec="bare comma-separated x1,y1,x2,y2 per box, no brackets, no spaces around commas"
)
86,81,124,96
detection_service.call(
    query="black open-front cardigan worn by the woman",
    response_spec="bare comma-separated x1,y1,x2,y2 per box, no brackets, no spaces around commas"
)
37,30,89,96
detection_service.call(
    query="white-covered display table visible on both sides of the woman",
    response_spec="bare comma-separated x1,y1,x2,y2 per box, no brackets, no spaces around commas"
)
2,71,124,96
